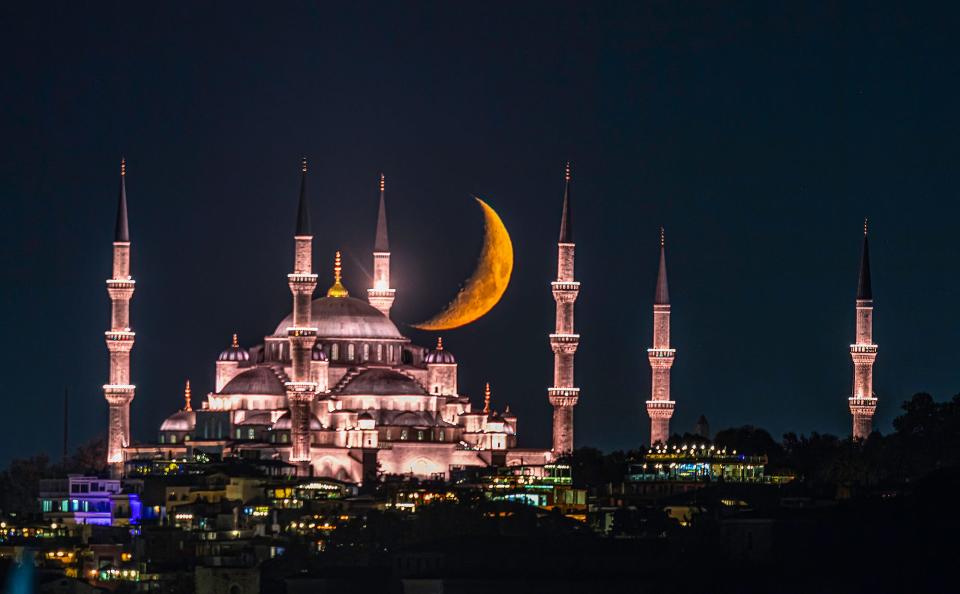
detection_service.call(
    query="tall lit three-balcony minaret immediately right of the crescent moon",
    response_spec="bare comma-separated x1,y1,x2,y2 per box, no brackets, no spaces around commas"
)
547,163,580,455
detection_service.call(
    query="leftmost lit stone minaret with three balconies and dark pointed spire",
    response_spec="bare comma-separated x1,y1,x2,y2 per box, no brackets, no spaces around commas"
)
103,160,136,477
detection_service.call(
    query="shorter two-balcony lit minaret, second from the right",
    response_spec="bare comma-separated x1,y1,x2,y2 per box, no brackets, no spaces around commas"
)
647,227,677,445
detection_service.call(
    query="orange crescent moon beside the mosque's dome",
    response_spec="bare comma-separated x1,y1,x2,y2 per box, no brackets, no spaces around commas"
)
413,196,513,330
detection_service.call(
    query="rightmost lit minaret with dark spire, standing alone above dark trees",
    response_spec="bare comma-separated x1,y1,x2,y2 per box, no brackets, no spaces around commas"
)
849,220,877,439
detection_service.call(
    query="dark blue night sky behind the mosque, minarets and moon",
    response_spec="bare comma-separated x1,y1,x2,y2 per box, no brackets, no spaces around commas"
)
0,2,960,460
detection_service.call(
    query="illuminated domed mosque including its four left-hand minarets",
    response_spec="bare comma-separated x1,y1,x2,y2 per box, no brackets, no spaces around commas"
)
103,160,579,482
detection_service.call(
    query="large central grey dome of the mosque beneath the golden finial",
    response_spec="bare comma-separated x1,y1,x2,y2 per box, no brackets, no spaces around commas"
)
274,297,404,340
